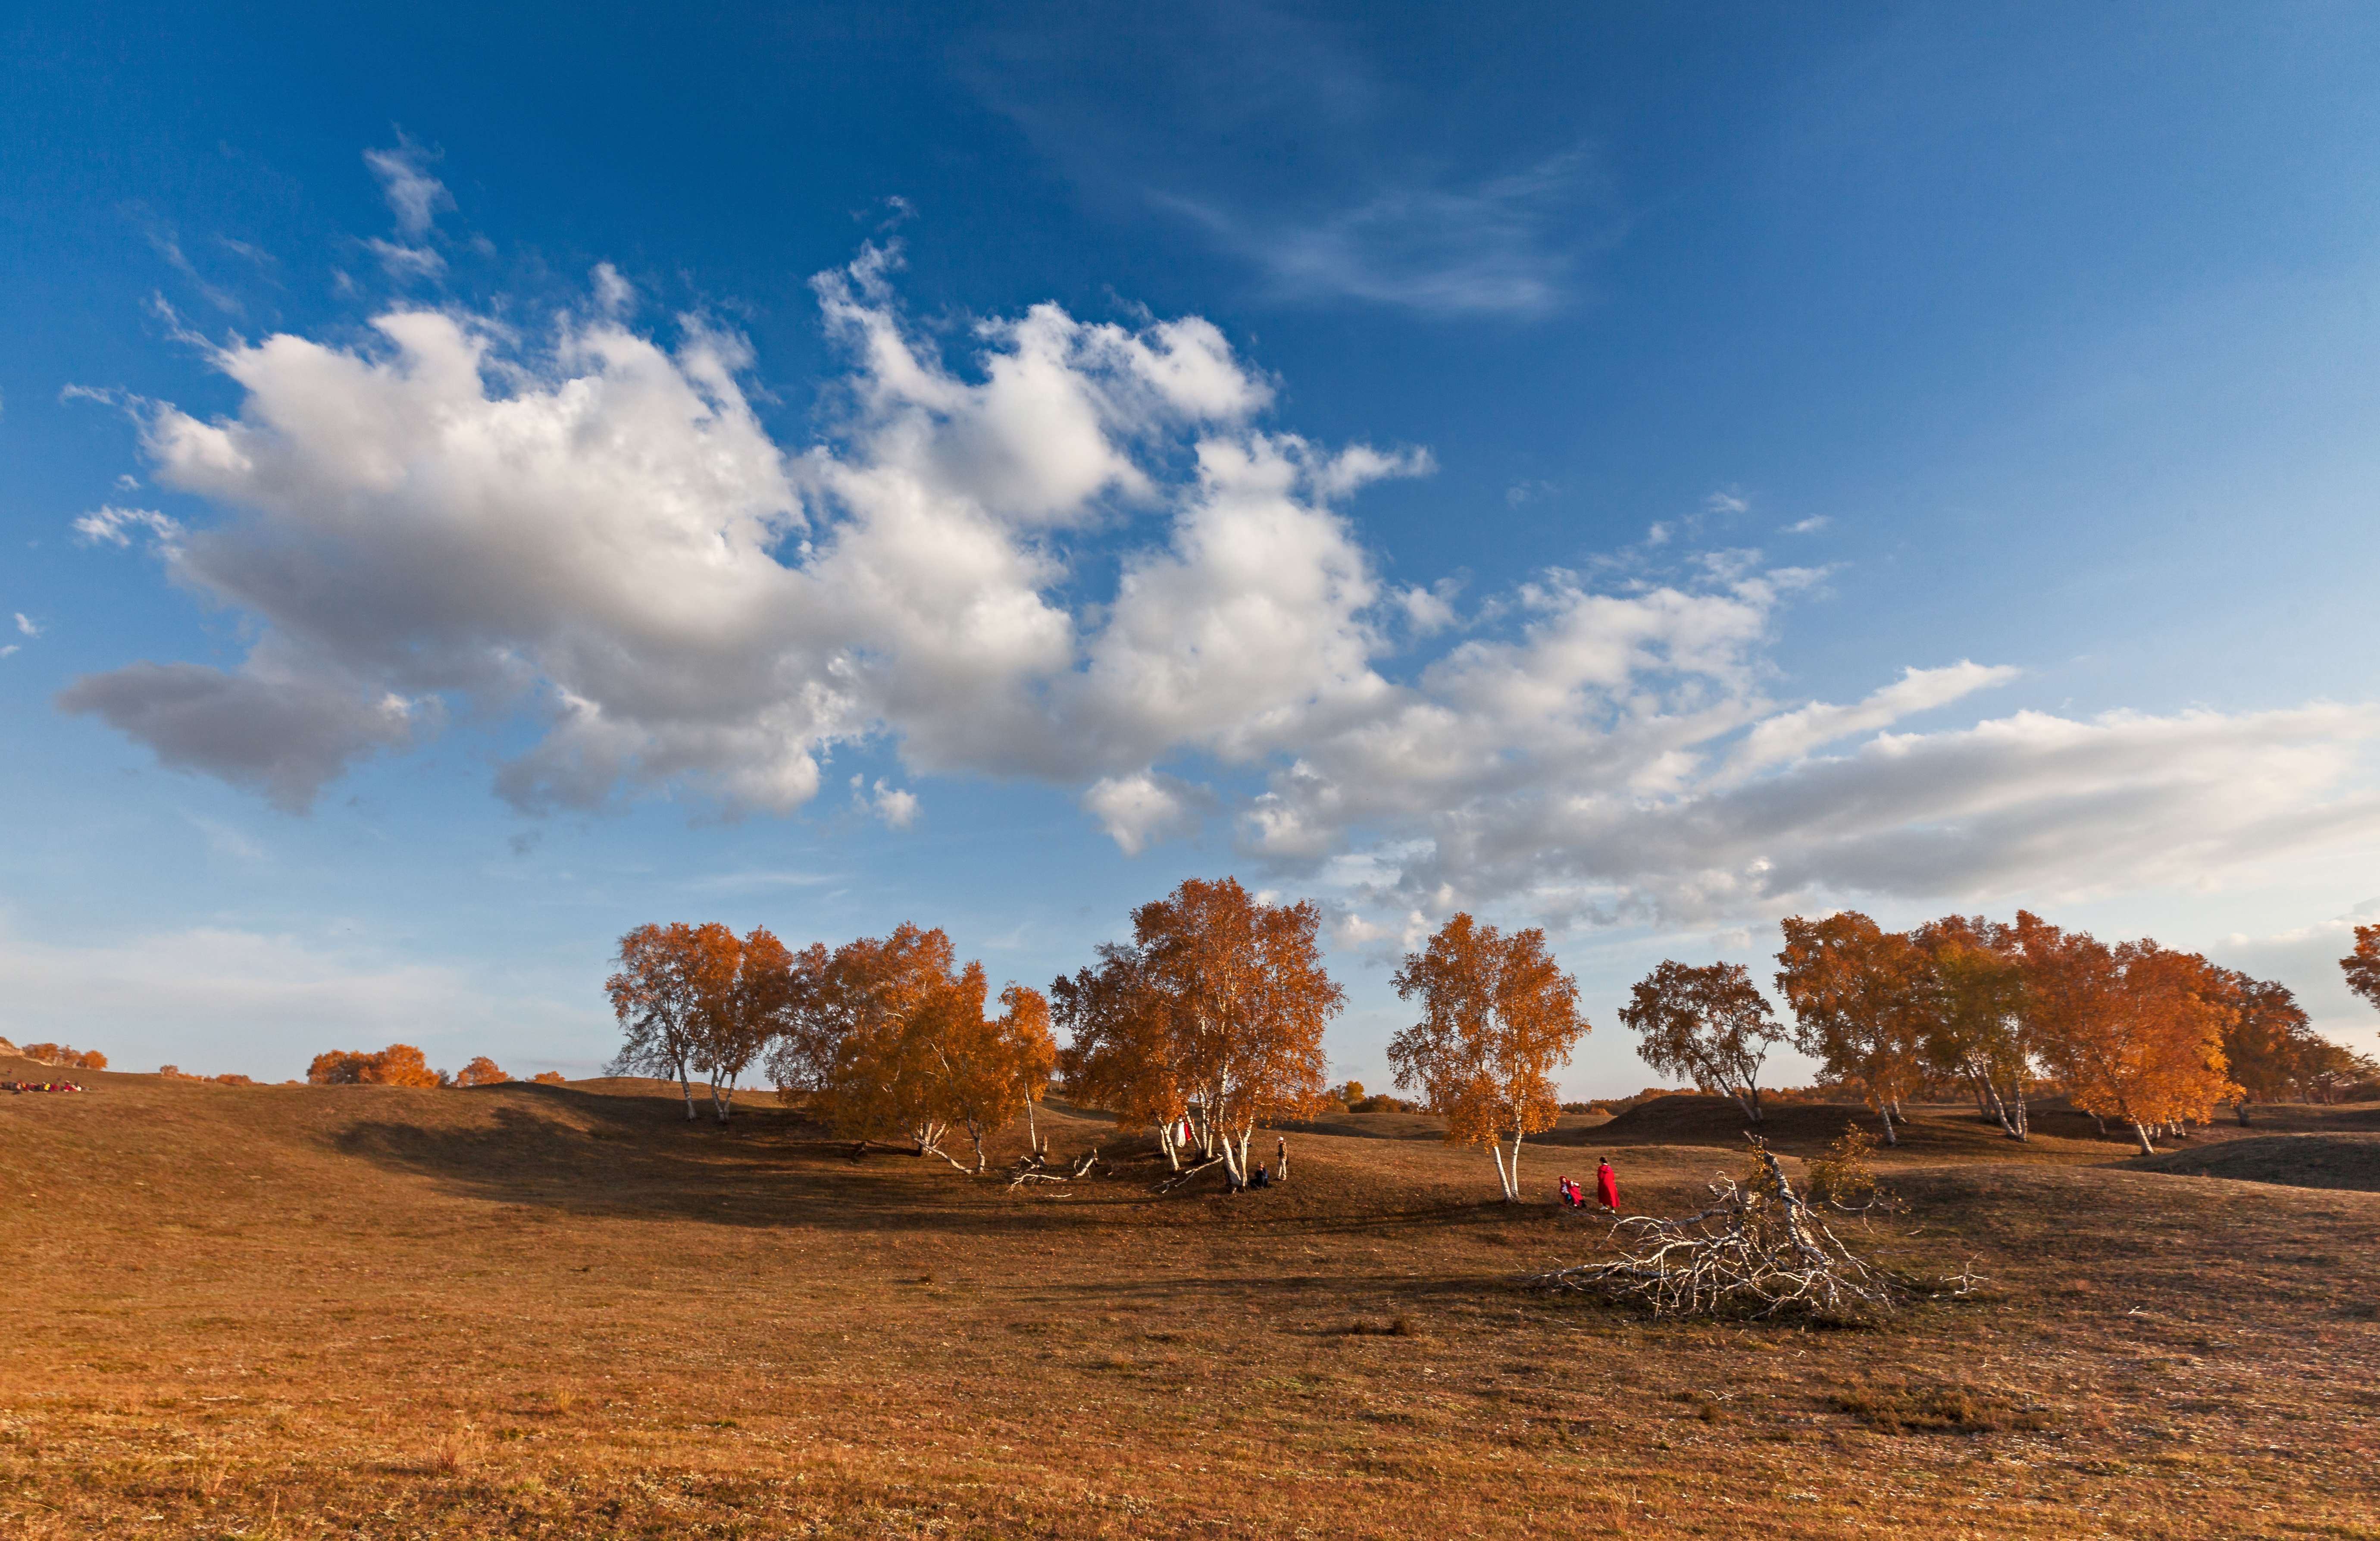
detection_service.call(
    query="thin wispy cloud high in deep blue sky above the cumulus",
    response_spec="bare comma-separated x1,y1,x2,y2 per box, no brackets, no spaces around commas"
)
971,5,1628,317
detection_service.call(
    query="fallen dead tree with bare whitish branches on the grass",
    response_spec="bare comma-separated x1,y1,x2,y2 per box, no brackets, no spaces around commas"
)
1523,1138,1980,1322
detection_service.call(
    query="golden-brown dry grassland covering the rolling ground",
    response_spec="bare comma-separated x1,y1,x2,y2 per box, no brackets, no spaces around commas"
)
0,1062,2380,1538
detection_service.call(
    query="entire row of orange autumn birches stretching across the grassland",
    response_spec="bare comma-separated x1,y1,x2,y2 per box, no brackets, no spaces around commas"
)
595,877,2380,1198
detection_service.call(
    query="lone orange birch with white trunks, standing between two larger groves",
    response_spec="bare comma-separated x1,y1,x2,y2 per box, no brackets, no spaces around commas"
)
1388,915,1588,1203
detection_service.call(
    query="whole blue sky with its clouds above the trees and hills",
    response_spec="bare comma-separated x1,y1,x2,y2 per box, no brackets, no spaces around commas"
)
0,5,2380,1093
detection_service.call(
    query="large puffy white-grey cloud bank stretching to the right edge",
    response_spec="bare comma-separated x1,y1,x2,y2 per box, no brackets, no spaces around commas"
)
62,249,2380,938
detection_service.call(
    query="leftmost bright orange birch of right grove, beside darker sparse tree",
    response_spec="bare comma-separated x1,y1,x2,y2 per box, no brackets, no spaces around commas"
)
1778,910,1923,1146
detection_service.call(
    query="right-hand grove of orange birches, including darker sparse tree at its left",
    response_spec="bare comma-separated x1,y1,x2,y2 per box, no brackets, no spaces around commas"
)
1621,910,2380,1150
